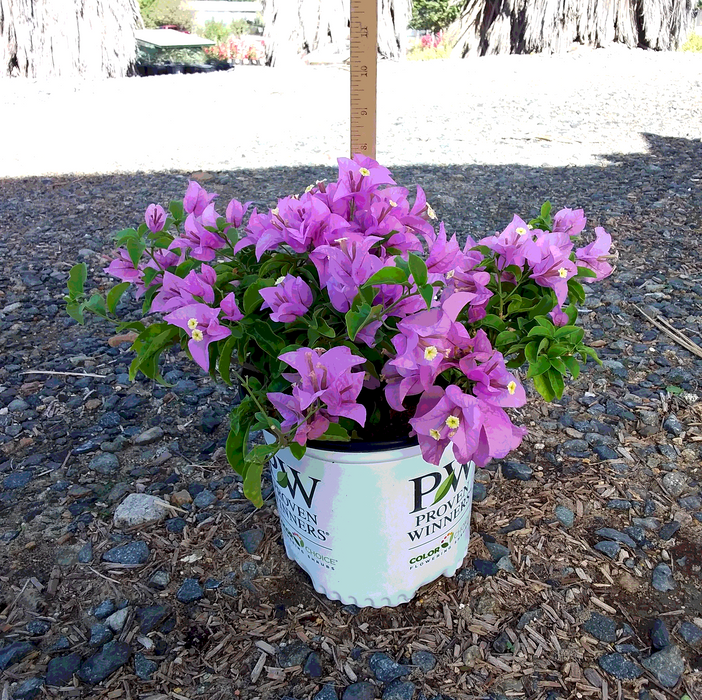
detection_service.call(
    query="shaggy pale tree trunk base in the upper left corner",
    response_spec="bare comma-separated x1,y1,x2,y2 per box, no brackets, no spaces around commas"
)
0,0,141,79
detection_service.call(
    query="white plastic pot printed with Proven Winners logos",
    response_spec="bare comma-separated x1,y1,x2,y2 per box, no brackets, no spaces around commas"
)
271,442,475,608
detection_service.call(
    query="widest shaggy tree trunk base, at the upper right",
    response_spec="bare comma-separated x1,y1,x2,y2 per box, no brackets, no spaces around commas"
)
451,0,694,57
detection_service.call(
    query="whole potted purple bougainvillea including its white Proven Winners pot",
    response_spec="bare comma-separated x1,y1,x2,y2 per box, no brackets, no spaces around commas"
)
66,155,612,607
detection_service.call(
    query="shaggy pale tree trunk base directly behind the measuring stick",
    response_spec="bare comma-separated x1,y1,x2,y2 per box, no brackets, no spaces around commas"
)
263,0,412,65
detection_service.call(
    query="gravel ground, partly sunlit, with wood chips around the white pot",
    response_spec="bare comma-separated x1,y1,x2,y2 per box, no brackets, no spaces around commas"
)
0,49,702,700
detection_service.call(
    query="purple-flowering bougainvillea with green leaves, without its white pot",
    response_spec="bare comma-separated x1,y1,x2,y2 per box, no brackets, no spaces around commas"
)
66,155,612,505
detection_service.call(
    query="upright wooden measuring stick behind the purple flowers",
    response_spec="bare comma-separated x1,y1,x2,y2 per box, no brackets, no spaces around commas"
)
351,0,378,159
